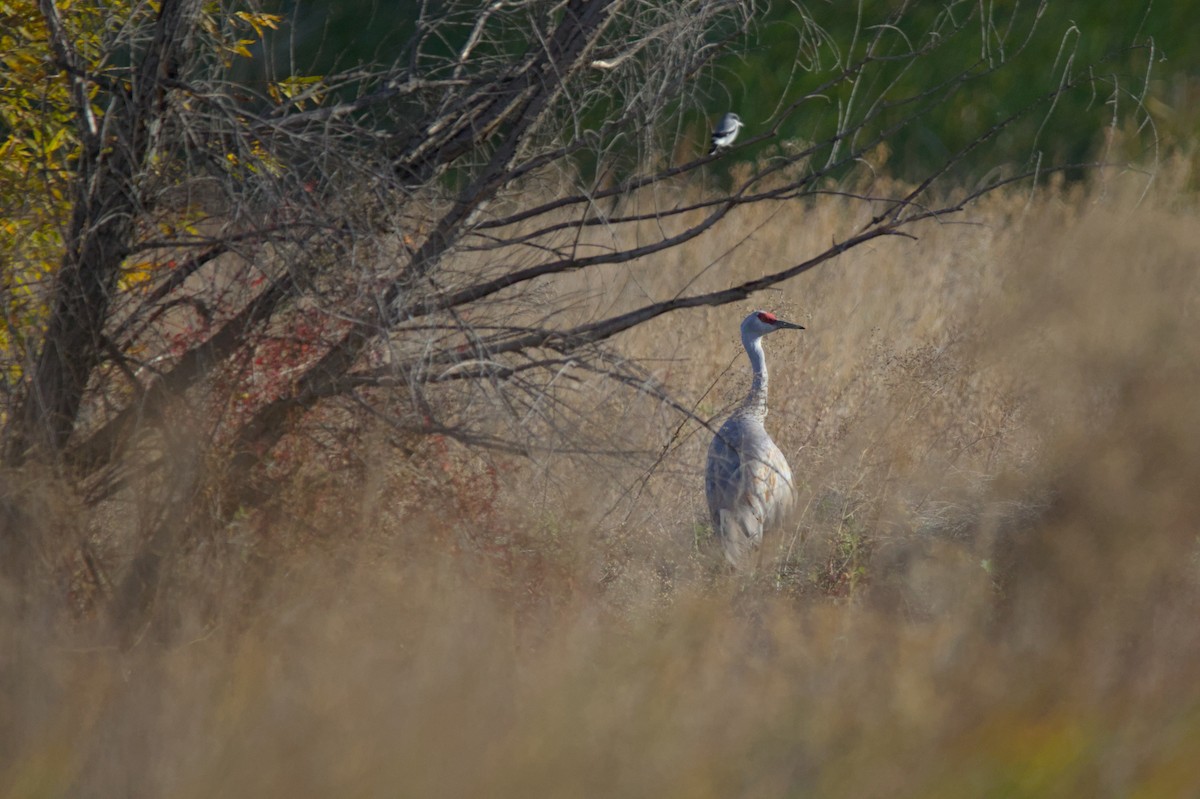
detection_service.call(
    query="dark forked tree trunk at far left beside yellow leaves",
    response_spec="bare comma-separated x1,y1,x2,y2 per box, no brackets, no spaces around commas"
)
4,0,199,465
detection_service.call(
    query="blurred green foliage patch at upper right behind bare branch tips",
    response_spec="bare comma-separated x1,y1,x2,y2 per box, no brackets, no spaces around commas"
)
710,0,1171,179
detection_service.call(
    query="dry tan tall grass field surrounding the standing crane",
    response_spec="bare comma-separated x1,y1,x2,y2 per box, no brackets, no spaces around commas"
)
0,166,1200,797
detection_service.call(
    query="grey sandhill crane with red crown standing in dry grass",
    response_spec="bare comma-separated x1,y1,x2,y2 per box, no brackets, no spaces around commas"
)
704,311,804,567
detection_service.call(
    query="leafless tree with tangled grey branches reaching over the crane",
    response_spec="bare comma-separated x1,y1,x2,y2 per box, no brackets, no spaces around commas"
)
5,0,1152,623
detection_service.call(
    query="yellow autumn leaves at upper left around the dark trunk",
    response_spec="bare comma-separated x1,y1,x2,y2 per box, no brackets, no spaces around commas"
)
0,0,282,357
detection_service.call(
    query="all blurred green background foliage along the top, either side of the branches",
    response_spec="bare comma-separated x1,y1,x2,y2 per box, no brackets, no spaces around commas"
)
258,0,1185,180
